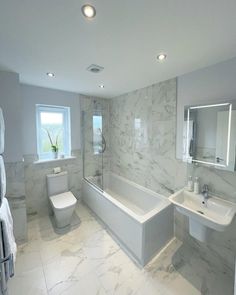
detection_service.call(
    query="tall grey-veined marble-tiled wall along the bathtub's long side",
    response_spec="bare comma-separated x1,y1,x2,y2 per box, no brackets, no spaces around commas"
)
110,79,186,196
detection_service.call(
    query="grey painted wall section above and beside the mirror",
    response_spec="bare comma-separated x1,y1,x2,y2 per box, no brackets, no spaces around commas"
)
176,58,236,159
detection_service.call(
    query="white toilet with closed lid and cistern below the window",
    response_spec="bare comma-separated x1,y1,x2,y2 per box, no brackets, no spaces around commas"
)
47,171,77,228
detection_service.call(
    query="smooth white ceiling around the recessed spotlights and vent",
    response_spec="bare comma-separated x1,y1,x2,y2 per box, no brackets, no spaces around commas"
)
0,0,236,97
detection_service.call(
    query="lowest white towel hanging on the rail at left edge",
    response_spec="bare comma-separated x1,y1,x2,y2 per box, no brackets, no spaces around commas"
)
0,198,17,279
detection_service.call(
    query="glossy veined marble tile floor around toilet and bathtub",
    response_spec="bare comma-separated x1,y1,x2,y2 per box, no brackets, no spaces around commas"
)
9,204,233,295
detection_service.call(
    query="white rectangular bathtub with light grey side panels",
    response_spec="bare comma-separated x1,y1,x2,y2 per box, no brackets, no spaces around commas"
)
82,173,173,266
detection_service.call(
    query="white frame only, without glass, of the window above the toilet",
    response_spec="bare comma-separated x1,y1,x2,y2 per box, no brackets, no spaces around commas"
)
36,104,71,160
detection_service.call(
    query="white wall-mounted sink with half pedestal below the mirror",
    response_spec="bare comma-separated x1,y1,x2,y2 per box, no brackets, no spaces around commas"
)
169,189,236,242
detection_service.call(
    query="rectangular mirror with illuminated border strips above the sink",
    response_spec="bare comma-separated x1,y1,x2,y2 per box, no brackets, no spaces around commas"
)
183,102,236,171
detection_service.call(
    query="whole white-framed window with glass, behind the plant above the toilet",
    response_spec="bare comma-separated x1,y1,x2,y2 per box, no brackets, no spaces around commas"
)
36,105,71,160
